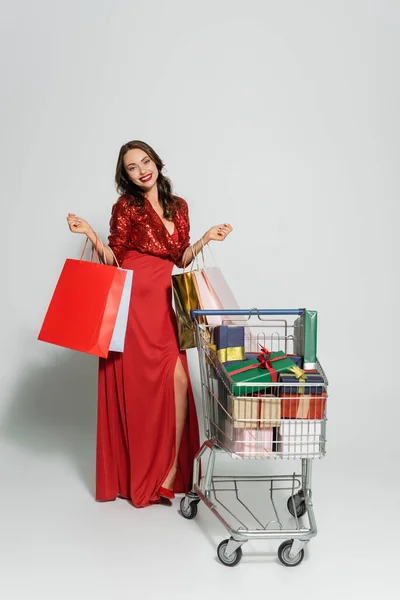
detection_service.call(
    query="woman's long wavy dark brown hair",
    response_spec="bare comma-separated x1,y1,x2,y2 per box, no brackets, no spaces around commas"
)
115,140,180,220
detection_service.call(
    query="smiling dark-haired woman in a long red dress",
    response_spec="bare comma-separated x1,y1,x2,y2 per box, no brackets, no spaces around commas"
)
67,141,232,507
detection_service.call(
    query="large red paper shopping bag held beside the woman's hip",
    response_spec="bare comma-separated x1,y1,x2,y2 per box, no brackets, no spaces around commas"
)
38,247,126,358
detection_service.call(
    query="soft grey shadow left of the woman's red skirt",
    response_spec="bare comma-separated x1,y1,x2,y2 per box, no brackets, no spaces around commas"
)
1,353,97,496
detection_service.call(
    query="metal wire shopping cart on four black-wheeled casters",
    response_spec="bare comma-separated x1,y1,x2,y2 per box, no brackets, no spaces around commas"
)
180,309,328,567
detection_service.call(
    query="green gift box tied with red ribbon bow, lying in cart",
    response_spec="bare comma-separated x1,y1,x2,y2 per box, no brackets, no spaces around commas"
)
225,351,294,396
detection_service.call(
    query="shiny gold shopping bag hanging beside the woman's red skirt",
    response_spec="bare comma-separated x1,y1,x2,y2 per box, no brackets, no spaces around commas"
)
172,271,199,350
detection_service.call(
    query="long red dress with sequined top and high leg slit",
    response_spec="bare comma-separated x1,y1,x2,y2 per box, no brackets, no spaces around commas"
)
96,197,199,507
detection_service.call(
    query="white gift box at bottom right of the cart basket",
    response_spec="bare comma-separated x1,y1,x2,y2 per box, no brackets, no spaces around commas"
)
278,419,322,458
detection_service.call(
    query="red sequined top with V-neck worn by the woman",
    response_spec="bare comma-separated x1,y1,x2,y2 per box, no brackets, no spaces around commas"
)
108,196,190,267
